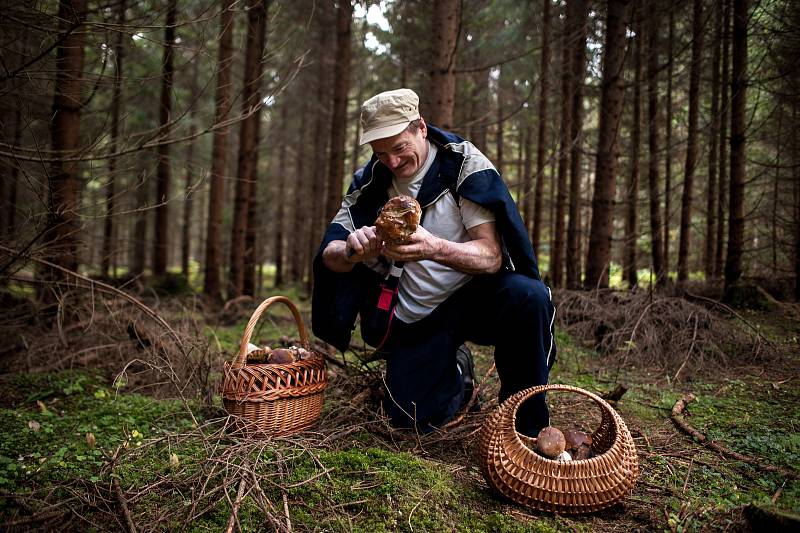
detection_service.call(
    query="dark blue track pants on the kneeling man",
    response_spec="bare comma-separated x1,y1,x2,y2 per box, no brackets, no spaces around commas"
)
386,272,556,436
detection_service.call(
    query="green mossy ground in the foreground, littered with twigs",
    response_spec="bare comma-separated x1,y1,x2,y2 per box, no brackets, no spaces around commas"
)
0,294,800,532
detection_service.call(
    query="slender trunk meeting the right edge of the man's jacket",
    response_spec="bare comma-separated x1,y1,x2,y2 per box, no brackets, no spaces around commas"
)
531,0,551,251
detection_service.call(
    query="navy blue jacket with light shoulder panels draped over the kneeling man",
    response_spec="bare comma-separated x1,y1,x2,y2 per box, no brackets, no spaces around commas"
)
311,125,541,351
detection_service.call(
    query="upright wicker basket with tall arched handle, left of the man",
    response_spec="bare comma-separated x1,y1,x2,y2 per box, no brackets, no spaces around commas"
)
222,296,328,437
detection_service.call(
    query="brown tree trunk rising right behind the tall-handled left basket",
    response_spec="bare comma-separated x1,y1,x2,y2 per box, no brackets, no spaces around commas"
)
239,0,268,296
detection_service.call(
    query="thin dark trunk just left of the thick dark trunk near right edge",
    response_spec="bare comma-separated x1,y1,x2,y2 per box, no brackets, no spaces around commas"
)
714,0,731,278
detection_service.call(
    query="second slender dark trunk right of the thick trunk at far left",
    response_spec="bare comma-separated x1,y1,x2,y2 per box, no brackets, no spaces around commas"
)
153,0,178,276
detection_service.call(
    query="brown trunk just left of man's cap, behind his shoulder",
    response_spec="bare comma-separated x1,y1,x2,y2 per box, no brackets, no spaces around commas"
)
325,0,353,227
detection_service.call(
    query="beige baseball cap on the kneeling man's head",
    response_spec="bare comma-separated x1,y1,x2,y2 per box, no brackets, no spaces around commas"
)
358,89,419,144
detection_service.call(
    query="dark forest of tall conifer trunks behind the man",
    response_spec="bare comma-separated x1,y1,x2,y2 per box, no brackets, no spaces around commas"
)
0,0,800,300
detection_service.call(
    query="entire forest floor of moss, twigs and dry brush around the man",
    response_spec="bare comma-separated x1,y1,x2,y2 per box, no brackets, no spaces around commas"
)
0,280,800,532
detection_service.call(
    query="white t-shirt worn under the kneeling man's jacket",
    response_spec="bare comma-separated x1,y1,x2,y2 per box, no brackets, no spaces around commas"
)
389,141,495,323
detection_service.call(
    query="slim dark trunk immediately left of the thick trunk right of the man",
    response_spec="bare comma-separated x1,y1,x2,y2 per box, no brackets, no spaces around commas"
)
567,0,588,289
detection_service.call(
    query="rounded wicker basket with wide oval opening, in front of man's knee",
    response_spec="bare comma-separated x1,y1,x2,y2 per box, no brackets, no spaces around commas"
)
479,385,639,514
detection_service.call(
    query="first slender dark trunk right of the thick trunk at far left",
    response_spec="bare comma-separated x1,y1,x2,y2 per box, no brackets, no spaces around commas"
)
100,0,127,276
